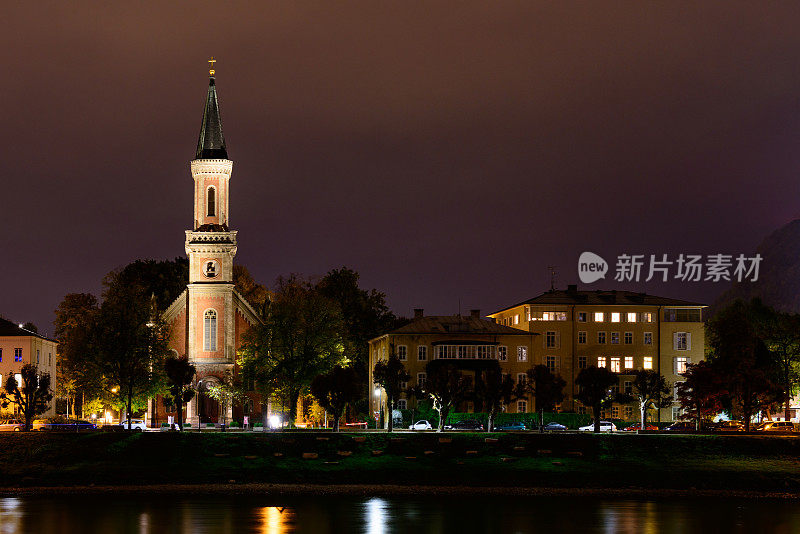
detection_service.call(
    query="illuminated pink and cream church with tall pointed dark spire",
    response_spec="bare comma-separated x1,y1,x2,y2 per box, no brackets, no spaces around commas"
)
147,59,260,426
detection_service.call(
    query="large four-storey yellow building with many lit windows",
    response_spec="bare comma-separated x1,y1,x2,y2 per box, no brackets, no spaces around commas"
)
489,285,705,421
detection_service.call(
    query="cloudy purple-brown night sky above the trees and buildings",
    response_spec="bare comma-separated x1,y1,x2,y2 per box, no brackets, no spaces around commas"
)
6,1,800,332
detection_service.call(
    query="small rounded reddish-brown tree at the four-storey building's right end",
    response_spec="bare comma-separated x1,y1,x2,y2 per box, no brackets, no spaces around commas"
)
678,360,727,430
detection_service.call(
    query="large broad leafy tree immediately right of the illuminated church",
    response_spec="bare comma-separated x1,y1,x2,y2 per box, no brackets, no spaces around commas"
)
239,275,347,428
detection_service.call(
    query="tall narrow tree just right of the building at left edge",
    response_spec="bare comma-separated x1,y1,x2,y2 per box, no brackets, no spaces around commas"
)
55,293,102,416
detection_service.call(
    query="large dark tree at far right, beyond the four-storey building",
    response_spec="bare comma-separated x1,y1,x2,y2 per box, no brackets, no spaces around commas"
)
706,301,783,431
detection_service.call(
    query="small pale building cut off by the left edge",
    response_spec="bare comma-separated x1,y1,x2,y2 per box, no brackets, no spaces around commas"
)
0,318,58,417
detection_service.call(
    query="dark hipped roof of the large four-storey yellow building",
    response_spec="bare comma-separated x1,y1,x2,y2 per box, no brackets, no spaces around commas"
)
491,288,705,315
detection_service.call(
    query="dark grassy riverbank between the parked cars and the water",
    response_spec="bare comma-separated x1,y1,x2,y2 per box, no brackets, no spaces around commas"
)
0,432,800,495
